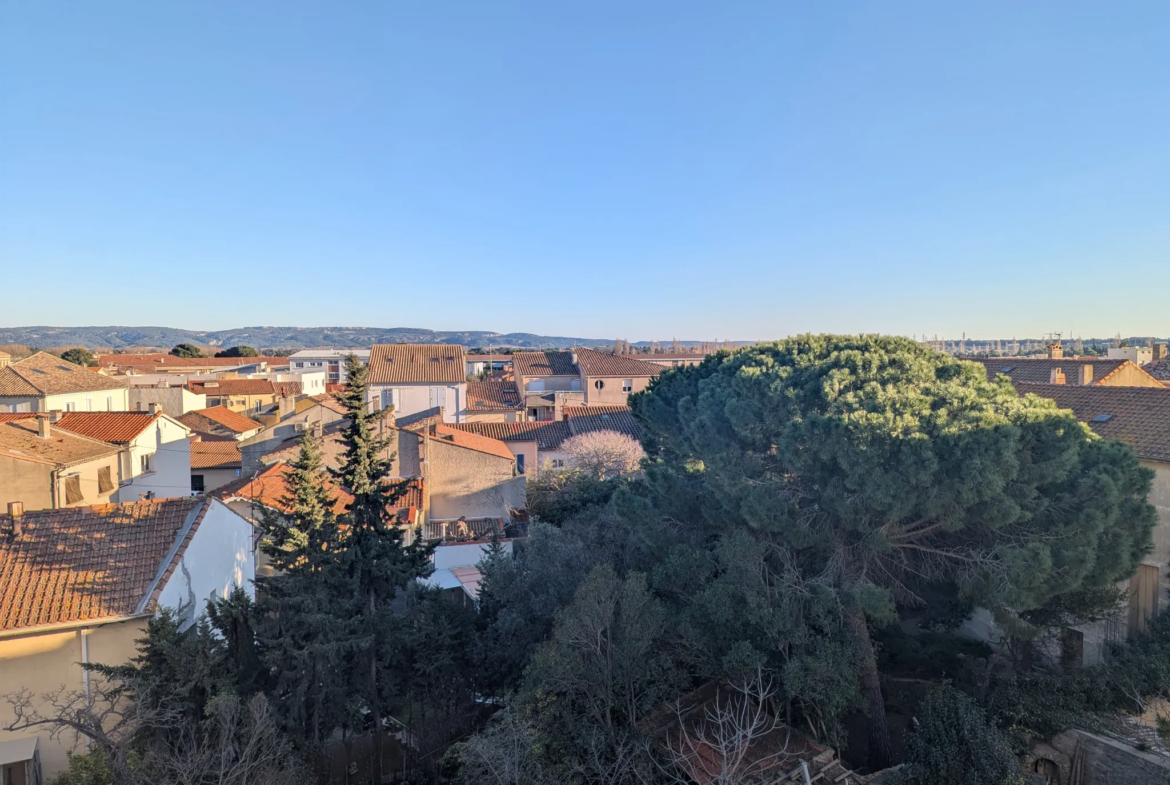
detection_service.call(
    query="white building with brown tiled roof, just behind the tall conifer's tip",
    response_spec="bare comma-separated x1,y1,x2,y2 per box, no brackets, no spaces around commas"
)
367,344,467,422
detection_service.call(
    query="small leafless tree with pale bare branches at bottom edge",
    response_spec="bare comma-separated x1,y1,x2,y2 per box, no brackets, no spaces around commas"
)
665,672,790,785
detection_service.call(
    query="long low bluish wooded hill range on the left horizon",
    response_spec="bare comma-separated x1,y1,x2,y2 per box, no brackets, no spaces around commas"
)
0,326,613,350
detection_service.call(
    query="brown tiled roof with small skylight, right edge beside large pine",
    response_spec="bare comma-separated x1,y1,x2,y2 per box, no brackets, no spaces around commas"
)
1016,384,1170,462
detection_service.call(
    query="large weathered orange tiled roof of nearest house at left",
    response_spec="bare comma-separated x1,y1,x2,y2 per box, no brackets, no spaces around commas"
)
0,498,212,631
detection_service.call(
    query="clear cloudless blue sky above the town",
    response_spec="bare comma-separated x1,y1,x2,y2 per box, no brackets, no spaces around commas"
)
0,0,1170,340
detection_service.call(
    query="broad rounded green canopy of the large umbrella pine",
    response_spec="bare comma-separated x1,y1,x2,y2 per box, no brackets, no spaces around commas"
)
634,336,1155,612
